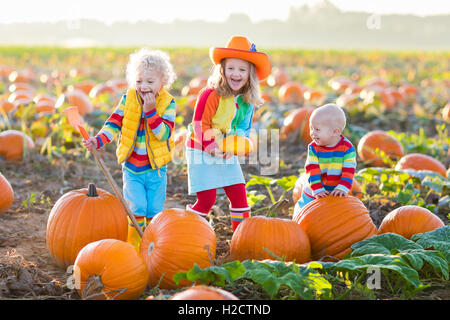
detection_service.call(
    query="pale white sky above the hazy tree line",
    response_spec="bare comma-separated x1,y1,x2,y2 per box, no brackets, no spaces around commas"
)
0,0,450,23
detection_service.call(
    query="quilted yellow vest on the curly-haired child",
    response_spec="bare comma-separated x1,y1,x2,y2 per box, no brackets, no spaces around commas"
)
116,88,174,169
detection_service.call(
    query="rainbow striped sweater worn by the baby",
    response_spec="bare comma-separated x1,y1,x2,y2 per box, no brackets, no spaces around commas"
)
303,135,356,197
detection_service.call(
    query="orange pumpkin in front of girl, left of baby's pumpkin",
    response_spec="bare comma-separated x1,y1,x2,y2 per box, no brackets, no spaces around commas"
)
230,216,311,263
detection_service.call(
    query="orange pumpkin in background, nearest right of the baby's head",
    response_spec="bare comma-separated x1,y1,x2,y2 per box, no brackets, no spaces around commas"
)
357,130,403,167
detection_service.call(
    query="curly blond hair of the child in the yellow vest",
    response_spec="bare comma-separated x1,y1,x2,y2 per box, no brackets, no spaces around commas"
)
126,48,176,88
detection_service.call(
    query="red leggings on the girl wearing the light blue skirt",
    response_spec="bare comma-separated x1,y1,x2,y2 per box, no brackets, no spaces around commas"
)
192,183,248,214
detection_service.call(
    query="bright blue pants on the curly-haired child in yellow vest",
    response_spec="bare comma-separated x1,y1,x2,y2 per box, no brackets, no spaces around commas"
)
123,166,167,218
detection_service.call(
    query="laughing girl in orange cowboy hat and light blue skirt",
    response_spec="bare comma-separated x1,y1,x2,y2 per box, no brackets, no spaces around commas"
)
186,36,271,231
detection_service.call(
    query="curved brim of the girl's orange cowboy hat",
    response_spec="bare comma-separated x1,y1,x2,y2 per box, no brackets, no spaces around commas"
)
209,48,271,81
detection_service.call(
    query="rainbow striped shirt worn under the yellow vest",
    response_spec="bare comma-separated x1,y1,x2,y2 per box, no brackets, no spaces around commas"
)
96,94,176,173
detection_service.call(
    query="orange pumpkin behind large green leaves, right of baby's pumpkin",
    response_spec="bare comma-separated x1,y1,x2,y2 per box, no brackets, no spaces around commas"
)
378,205,444,239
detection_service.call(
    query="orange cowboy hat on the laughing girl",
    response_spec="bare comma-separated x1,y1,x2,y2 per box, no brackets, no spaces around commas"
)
209,36,271,80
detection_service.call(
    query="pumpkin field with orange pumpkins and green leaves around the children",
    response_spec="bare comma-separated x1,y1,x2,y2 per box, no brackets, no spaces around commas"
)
0,47,450,303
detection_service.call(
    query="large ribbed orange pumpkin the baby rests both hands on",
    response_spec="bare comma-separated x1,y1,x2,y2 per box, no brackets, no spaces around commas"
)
292,196,377,260
